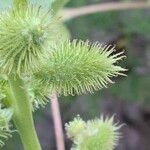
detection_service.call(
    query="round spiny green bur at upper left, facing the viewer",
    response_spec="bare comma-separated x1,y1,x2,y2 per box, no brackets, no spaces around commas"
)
0,6,56,75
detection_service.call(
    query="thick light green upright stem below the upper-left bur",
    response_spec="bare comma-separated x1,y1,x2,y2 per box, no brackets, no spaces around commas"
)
9,75,41,150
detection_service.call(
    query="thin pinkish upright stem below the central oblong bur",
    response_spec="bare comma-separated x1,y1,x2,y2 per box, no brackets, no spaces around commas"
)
50,93,65,150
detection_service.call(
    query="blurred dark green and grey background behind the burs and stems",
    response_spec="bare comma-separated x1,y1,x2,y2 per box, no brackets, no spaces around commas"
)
0,0,150,150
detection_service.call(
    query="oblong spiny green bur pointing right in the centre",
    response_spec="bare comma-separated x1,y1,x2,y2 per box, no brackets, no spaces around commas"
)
35,40,125,96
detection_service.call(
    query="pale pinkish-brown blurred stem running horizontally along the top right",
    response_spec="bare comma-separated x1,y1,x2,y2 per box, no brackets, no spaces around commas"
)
62,2,150,20
